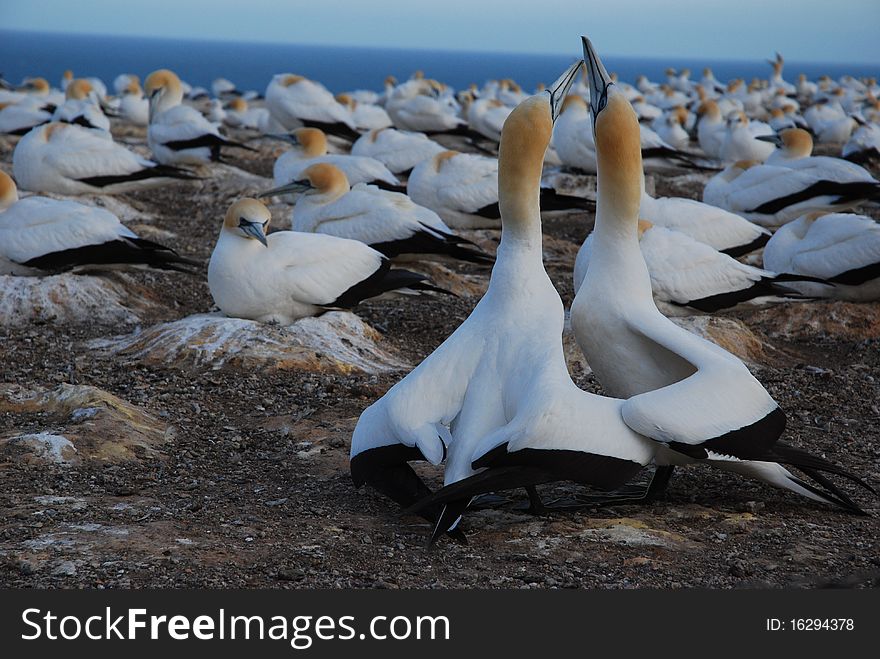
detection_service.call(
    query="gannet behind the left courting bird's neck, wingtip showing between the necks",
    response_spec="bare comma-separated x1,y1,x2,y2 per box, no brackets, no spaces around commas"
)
406,151,590,229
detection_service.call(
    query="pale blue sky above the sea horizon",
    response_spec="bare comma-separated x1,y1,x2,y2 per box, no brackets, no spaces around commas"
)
0,0,880,64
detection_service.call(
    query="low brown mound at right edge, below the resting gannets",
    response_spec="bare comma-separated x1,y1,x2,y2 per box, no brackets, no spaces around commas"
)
750,300,880,341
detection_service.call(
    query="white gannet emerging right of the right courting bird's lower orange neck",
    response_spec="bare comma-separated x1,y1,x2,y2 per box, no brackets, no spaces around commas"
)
639,174,770,257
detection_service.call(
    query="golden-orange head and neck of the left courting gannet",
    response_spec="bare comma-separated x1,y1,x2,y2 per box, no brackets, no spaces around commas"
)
498,93,553,248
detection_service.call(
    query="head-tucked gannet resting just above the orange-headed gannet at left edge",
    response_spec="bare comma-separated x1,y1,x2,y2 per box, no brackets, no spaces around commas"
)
12,122,194,194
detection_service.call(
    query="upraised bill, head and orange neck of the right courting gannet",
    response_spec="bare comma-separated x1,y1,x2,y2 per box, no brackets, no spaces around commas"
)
581,37,643,222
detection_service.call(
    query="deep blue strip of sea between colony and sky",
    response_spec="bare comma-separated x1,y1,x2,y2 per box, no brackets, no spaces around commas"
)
0,30,880,92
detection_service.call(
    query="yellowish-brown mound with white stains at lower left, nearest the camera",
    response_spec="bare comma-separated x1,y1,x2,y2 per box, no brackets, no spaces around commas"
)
0,383,173,464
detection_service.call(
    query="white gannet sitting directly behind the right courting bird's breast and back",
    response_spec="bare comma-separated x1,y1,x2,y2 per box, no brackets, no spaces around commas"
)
574,220,828,316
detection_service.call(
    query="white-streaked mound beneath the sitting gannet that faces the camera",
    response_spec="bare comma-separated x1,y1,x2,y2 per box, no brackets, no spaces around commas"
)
89,311,410,373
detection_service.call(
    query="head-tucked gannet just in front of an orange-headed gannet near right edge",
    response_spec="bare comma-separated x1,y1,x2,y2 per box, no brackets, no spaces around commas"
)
703,156,880,227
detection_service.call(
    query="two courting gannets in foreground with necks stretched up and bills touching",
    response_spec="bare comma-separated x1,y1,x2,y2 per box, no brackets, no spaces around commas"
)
351,40,859,540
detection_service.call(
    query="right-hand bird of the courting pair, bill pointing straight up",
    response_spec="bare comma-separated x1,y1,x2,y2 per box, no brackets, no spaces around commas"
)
571,39,860,512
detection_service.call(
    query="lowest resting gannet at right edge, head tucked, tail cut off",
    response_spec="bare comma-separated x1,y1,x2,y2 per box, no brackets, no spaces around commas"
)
764,212,880,302
